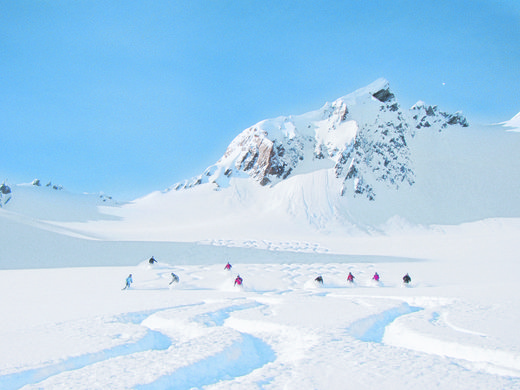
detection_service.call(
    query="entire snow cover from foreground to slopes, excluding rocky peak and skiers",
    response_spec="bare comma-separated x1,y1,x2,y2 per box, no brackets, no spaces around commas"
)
0,79,520,390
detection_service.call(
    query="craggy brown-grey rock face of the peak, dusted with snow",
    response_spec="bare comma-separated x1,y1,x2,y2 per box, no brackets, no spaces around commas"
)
172,79,468,200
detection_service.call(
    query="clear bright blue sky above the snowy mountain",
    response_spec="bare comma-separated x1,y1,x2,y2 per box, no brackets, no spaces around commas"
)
0,0,520,200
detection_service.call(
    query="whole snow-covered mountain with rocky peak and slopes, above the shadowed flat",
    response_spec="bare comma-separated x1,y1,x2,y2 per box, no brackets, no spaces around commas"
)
4,79,520,247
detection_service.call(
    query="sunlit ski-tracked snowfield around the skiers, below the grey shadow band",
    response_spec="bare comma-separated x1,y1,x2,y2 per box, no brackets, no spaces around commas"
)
0,244,520,389
